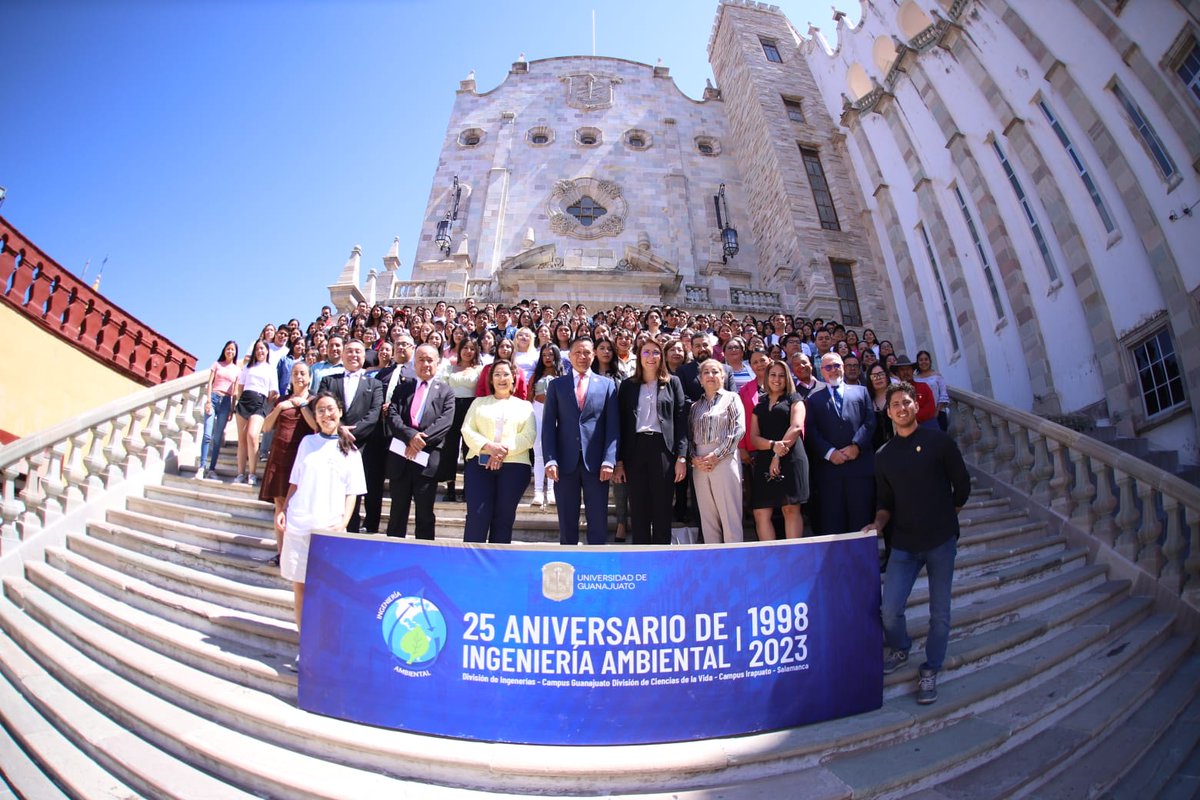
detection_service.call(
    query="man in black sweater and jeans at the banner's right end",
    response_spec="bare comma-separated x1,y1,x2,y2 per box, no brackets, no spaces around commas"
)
864,383,971,704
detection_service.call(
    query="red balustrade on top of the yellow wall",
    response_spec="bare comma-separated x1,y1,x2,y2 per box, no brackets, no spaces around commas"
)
0,217,196,386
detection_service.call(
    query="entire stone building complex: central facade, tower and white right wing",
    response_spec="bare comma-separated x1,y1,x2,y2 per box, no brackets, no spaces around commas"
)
330,0,1200,462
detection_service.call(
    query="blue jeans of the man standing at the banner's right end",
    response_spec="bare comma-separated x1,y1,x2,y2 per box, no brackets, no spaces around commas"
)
881,537,959,672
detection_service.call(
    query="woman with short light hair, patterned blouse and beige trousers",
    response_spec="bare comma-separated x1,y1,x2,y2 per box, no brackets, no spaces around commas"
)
689,359,746,545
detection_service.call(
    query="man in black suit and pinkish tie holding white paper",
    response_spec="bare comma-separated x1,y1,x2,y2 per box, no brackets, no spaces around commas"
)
388,344,454,540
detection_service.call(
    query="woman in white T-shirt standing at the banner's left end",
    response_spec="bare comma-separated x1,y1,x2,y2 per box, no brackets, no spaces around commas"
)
280,390,367,670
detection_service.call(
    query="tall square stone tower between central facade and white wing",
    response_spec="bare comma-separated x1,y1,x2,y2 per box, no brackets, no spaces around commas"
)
708,0,892,330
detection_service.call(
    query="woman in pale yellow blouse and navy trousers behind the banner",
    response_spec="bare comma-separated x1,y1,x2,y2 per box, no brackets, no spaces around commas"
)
462,361,538,545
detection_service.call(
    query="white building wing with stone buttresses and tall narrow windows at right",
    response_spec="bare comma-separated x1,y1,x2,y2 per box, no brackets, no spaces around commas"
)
796,0,1200,463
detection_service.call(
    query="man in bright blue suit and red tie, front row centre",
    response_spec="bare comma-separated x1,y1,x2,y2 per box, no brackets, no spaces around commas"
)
541,336,620,545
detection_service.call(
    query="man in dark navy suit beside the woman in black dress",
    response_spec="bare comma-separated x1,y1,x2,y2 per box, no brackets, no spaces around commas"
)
804,353,875,535
